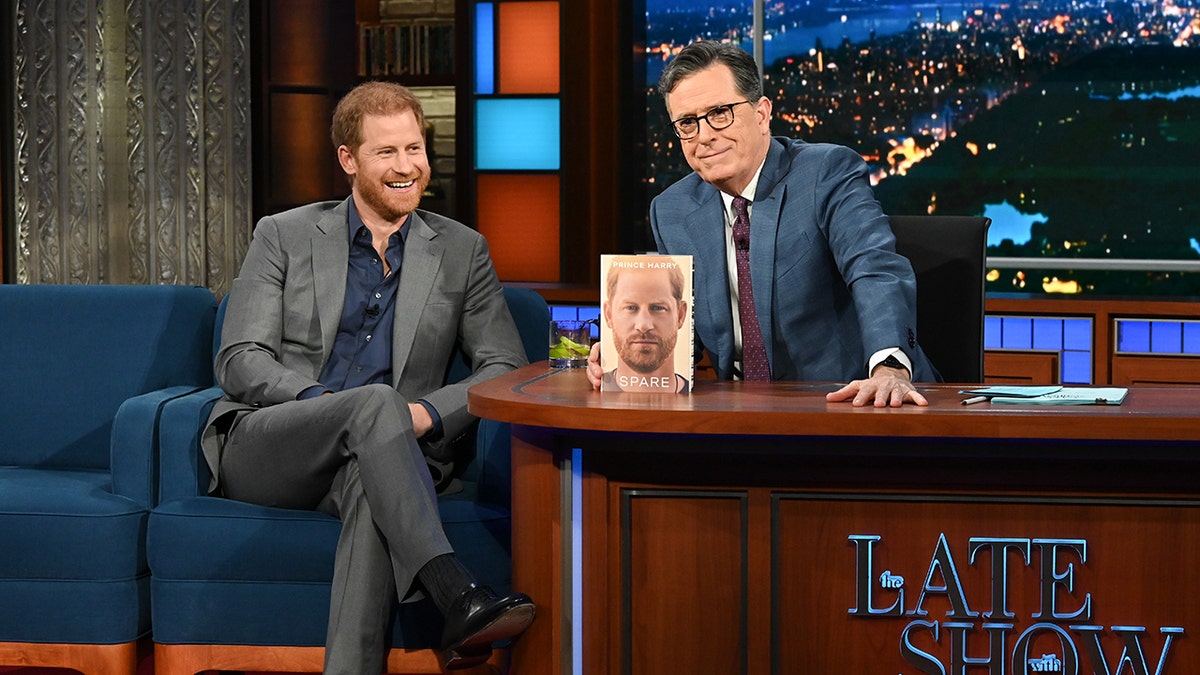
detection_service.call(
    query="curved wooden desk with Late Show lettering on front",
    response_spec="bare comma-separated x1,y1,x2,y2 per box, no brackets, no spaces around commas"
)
470,363,1200,675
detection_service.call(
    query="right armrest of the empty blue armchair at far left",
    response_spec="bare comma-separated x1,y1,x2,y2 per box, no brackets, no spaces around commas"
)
108,384,207,509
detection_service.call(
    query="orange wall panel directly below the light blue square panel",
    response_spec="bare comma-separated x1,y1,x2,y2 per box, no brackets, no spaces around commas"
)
476,174,562,282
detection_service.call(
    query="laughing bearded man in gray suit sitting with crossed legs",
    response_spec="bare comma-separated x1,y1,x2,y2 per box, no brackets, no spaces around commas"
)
203,82,534,674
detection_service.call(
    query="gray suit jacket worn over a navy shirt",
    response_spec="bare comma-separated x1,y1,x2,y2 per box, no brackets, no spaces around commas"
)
203,201,527,490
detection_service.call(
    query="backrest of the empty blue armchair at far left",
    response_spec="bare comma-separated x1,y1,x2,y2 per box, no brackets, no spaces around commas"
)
0,285,216,470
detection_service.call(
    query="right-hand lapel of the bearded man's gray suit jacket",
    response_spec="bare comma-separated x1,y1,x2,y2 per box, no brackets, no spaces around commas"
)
391,211,444,387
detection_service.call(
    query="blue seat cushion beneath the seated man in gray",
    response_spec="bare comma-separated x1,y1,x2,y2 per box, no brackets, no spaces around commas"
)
149,496,511,649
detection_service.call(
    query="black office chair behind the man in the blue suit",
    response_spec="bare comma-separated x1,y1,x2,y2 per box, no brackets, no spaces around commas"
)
890,216,991,382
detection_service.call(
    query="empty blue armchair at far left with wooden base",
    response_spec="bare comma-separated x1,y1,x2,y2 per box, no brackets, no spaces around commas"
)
0,285,216,675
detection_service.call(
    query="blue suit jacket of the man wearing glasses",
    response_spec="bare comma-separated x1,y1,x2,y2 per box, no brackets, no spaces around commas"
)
650,137,938,382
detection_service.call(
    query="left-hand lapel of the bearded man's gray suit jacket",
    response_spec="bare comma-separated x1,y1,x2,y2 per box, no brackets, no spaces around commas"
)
312,198,350,354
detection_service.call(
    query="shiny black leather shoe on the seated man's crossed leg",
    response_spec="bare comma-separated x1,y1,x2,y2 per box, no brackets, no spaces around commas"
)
442,586,535,670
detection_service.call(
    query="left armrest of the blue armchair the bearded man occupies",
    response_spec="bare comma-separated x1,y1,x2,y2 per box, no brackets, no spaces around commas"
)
158,387,224,503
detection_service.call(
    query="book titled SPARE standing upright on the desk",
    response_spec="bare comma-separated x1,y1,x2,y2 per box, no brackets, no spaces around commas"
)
600,256,690,394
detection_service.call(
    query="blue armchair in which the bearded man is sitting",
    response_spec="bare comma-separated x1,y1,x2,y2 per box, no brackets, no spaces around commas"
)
148,287,550,675
